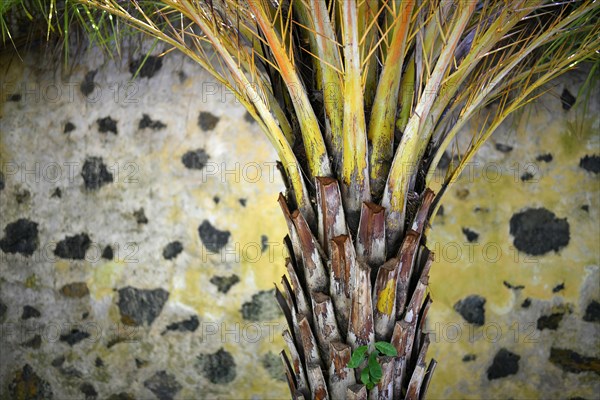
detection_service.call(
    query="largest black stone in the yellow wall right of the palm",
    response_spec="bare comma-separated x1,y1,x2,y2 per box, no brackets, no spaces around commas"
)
510,208,570,256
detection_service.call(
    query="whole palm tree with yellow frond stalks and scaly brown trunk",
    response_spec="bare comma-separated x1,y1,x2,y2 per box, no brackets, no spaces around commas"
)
0,0,600,399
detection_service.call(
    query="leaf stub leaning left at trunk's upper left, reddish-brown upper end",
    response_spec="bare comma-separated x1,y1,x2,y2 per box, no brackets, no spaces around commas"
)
292,210,328,292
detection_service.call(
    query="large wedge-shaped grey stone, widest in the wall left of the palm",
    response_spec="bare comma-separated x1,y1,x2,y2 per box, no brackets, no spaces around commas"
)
118,286,169,326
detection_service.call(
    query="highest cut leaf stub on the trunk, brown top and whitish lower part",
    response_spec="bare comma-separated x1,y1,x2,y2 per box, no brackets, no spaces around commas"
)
316,177,348,256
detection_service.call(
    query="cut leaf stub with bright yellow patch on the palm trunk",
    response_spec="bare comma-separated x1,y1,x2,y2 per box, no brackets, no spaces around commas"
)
373,258,400,342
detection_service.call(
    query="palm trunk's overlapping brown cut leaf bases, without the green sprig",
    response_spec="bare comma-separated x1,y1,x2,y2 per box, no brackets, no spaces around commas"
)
276,178,435,399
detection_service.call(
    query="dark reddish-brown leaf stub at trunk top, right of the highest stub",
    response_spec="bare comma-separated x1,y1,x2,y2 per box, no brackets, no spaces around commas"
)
356,202,386,268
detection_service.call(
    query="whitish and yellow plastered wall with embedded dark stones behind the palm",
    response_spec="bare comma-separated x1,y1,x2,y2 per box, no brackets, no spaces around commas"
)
0,39,600,400
